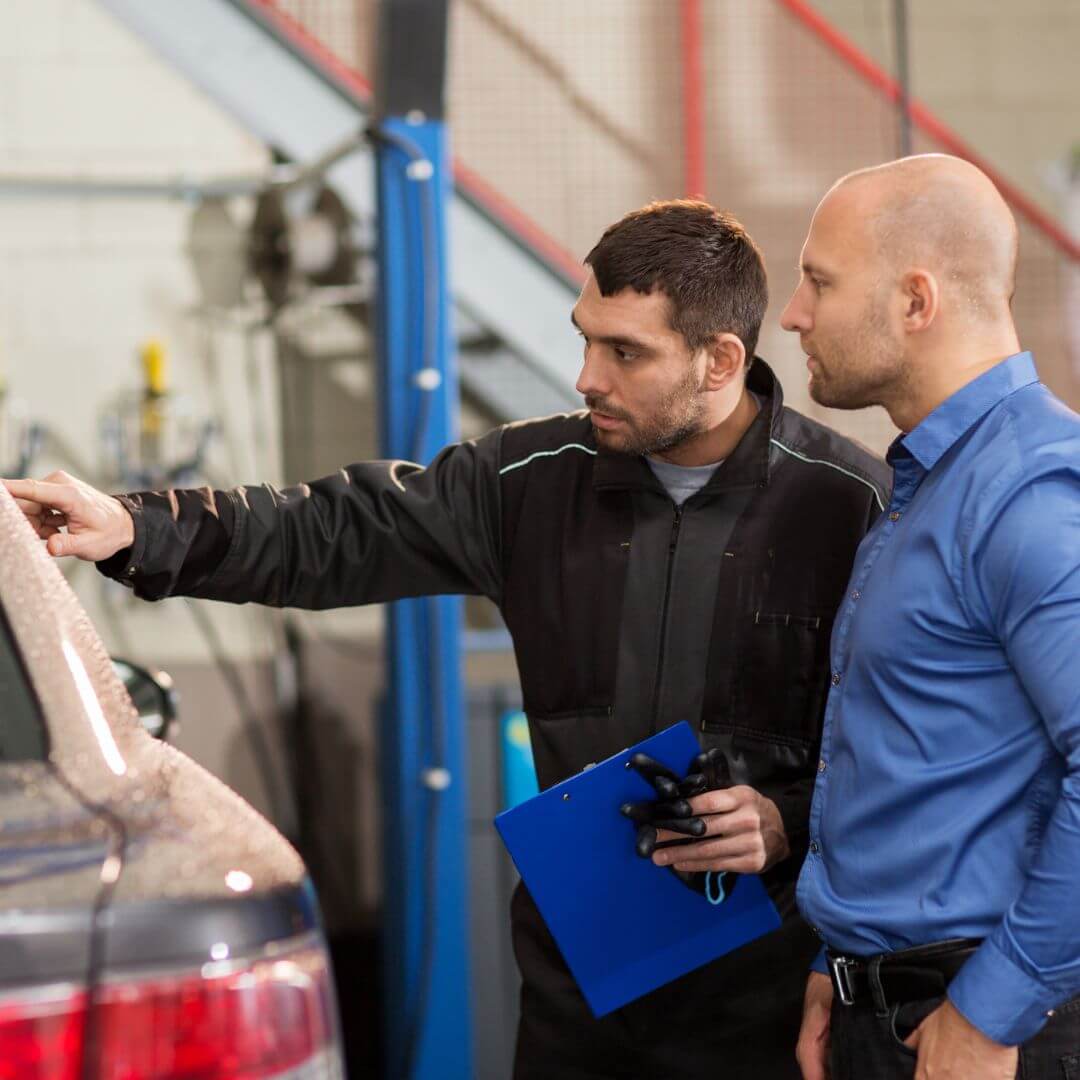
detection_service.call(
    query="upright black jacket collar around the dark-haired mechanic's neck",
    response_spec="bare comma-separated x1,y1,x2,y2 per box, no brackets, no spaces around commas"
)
593,356,784,494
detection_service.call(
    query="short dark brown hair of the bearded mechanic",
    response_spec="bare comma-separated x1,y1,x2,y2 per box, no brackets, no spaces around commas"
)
585,199,769,366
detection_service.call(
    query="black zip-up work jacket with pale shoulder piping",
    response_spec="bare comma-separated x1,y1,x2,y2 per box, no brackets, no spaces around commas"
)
102,360,890,1049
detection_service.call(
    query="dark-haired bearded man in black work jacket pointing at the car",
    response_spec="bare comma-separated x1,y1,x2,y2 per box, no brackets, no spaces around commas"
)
9,202,888,1080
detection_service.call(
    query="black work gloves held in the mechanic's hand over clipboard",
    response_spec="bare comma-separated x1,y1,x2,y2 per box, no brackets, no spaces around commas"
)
621,747,732,904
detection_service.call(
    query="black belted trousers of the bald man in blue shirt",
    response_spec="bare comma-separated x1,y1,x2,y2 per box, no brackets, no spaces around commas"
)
829,997,1080,1080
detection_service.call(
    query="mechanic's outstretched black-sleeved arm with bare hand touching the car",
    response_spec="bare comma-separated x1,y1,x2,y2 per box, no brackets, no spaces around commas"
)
6,431,501,608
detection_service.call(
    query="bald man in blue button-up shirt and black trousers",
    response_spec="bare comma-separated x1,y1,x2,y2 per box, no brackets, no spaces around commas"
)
782,156,1080,1080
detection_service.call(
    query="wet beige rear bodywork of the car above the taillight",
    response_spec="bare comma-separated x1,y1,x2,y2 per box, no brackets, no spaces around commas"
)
0,486,308,982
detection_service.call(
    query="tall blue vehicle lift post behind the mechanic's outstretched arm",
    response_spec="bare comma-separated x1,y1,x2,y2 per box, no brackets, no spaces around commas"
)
372,0,472,1080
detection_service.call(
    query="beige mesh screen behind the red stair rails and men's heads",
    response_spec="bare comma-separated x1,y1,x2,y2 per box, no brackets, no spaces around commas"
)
265,0,1080,451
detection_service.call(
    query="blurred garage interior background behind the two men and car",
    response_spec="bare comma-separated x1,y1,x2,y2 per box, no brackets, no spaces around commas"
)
0,0,1080,1080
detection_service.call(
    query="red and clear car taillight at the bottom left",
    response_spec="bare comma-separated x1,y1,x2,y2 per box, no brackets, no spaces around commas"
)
0,945,343,1080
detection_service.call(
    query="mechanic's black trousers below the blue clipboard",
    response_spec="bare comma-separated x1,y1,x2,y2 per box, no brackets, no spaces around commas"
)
512,889,812,1080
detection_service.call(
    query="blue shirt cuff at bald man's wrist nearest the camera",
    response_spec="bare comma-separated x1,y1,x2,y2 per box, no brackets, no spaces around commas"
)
948,939,1062,1047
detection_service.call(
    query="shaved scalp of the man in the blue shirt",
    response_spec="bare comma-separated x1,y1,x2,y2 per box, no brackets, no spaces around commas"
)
821,153,1017,320
